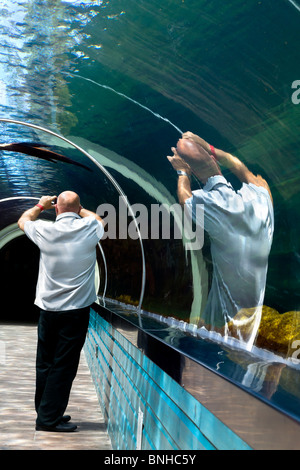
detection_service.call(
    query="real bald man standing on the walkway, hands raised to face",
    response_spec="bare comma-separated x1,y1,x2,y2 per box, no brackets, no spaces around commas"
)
18,191,104,432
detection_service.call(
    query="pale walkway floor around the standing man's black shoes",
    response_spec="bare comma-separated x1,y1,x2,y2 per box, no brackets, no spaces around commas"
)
0,324,111,450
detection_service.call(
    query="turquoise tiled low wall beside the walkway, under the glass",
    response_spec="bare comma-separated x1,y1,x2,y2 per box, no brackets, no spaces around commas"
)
85,310,250,450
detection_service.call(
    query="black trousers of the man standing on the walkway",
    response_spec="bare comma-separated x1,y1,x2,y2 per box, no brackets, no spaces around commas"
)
35,307,90,426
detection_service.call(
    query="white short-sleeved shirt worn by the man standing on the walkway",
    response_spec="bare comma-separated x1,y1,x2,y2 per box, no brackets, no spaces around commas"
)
24,212,104,311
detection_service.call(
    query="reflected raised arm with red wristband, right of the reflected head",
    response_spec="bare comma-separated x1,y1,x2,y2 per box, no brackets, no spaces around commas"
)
182,132,273,202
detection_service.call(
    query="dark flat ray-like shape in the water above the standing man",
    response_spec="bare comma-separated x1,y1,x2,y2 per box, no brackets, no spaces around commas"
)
0,142,92,171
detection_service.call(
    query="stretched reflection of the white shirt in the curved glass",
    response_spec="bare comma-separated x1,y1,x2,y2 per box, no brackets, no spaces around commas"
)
186,175,274,326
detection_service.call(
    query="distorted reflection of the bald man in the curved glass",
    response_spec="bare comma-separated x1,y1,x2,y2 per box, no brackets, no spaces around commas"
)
168,132,274,346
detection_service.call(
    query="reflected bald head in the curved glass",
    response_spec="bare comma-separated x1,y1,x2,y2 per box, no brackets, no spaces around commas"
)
177,139,222,183
